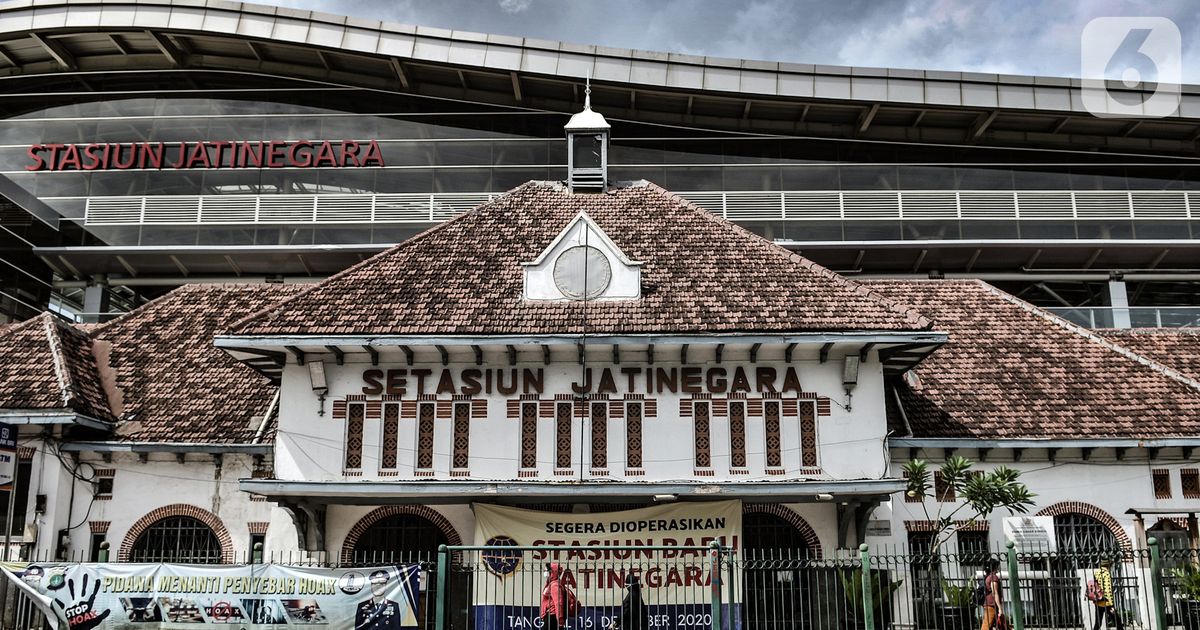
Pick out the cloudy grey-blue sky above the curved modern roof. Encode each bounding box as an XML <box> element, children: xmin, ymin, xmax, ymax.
<box><xmin>259</xmin><ymin>0</ymin><xmax>1200</xmax><ymax>83</ymax></box>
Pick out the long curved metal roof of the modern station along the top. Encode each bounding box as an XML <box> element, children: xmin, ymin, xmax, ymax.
<box><xmin>0</xmin><ymin>0</ymin><xmax>1200</xmax><ymax>155</ymax></box>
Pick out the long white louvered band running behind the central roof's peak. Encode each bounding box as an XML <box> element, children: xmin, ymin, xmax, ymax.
<box><xmin>84</xmin><ymin>191</ymin><xmax>1200</xmax><ymax>226</ymax></box>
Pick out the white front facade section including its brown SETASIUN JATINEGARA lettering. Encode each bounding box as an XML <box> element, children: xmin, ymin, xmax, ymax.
<box><xmin>275</xmin><ymin>346</ymin><xmax>887</xmax><ymax>481</ymax></box>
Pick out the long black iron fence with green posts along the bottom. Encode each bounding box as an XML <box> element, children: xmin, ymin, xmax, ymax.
<box><xmin>2</xmin><ymin>535</ymin><xmax>1200</xmax><ymax>630</ymax></box>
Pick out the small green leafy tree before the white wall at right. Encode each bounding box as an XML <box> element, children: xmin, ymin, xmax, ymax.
<box><xmin>904</xmin><ymin>455</ymin><xmax>1037</xmax><ymax>554</ymax></box>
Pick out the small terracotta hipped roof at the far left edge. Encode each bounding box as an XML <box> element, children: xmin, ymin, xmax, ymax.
<box><xmin>0</xmin><ymin>313</ymin><xmax>114</xmax><ymax>420</ymax></box>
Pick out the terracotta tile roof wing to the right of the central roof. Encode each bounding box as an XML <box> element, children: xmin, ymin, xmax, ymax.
<box><xmin>870</xmin><ymin>281</ymin><xmax>1200</xmax><ymax>439</ymax></box>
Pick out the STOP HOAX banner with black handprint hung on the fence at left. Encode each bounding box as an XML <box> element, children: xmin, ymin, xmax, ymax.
<box><xmin>6</xmin><ymin>563</ymin><xmax>420</xmax><ymax>630</ymax></box>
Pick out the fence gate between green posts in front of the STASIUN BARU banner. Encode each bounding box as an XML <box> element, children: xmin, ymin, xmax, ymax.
<box><xmin>433</xmin><ymin>545</ymin><xmax>729</xmax><ymax>630</ymax></box>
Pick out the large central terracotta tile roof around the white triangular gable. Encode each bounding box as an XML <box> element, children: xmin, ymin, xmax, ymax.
<box><xmin>234</xmin><ymin>182</ymin><xmax>929</xmax><ymax>335</ymax></box>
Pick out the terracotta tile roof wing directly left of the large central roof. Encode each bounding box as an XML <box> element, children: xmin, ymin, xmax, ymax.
<box><xmin>91</xmin><ymin>284</ymin><xmax>298</xmax><ymax>444</ymax></box>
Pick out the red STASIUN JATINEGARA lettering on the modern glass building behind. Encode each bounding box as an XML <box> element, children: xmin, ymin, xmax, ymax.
<box><xmin>25</xmin><ymin>140</ymin><xmax>384</xmax><ymax>170</ymax></box>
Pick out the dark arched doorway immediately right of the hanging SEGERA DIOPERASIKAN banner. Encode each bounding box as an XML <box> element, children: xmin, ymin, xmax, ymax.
<box><xmin>740</xmin><ymin>505</ymin><xmax>820</xmax><ymax>630</ymax></box>
